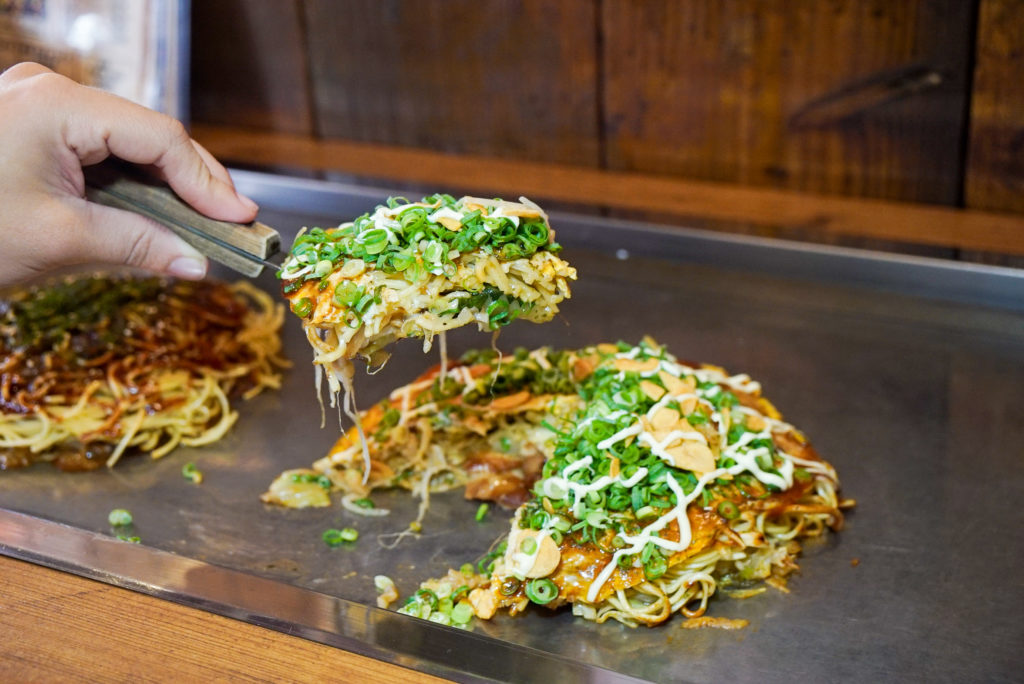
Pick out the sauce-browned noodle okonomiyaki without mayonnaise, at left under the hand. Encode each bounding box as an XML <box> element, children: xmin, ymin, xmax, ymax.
<box><xmin>0</xmin><ymin>275</ymin><xmax>286</xmax><ymax>470</ymax></box>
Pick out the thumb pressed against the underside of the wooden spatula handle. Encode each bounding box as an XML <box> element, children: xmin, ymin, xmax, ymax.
<box><xmin>77</xmin><ymin>202</ymin><xmax>207</xmax><ymax>281</ymax></box>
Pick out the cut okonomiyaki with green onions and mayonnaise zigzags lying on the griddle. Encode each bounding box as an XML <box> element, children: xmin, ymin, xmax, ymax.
<box><xmin>264</xmin><ymin>340</ymin><xmax>852</xmax><ymax>626</ymax></box>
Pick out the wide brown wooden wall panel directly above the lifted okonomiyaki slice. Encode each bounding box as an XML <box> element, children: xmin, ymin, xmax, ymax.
<box><xmin>306</xmin><ymin>0</ymin><xmax>599</xmax><ymax>165</ymax></box>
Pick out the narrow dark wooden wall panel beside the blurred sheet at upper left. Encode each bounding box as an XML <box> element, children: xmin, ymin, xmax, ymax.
<box><xmin>191</xmin><ymin>0</ymin><xmax>312</xmax><ymax>134</ymax></box>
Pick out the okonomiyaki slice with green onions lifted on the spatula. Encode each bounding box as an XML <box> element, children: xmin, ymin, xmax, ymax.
<box><xmin>279</xmin><ymin>195</ymin><xmax>575</xmax><ymax>481</ymax></box>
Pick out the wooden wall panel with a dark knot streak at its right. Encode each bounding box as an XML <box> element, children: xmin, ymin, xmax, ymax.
<box><xmin>602</xmin><ymin>0</ymin><xmax>972</xmax><ymax>204</ymax></box>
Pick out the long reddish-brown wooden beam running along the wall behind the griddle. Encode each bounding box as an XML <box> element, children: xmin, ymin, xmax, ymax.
<box><xmin>193</xmin><ymin>125</ymin><xmax>1024</xmax><ymax>254</ymax></box>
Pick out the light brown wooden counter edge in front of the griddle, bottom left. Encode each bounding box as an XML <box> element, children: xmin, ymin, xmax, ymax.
<box><xmin>0</xmin><ymin>556</ymin><xmax>441</xmax><ymax>684</ymax></box>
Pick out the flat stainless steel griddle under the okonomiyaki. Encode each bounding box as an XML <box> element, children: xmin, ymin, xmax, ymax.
<box><xmin>0</xmin><ymin>173</ymin><xmax>1024</xmax><ymax>682</ymax></box>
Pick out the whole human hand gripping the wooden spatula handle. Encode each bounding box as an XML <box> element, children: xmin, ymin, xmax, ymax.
<box><xmin>0</xmin><ymin>63</ymin><xmax>257</xmax><ymax>286</ymax></box>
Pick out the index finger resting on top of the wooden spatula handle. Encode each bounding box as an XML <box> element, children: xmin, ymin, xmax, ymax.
<box><xmin>55</xmin><ymin>81</ymin><xmax>258</xmax><ymax>222</ymax></box>
